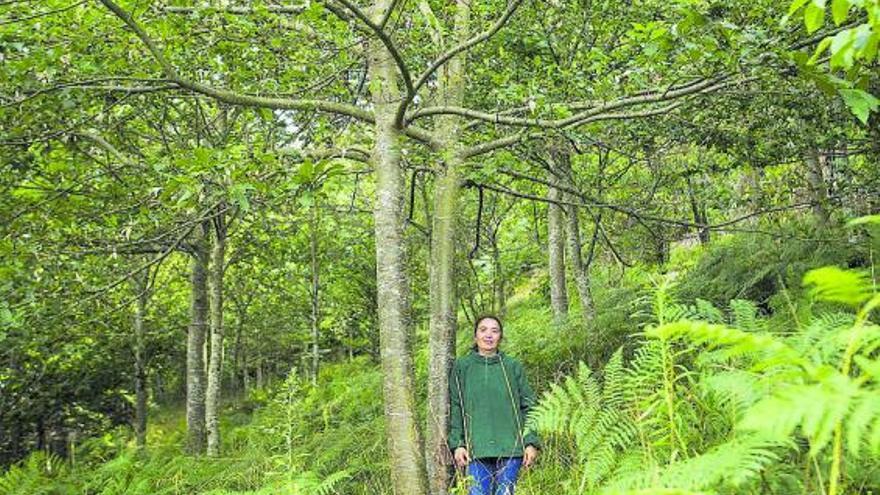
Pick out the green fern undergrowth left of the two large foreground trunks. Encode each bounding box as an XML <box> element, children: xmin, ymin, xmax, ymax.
<box><xmin>0</xmin><ymin>359</ymin><xmax>388</xmax><ymax>495</ymax></box>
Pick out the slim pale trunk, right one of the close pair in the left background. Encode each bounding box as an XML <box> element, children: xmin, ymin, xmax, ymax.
<box><xmin>205</xmin><ymin>211</ymin><xmax>226</xmax><ymax>457</ymax></box>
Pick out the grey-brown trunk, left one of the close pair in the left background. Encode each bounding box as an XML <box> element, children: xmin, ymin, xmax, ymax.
<box><xmin>186</xmin><ymin>223</ymin><xmax>209</xmax><ymax>454</ymax></box>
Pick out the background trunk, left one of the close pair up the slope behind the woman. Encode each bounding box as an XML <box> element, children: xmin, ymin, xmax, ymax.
<box><xmin>547</xmin><ymin>173</ymin><xmax>568</xmax><ymax>325</ymax></box>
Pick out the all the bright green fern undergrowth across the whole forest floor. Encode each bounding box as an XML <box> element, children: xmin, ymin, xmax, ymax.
<box><xmin>0</xmin><ymin>225</ymin><xmax>880</xmax><ymax>495</ymax></box>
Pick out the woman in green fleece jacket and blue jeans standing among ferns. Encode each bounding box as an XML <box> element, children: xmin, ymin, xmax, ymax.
<box><xmin>449</xmin><ymin>316</ymin><xmax>539</xmax><ymax>495</ymax></box>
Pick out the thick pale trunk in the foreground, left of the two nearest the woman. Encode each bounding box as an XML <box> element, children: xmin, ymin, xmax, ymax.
<box><xmin>368</xmin><ymin>13</ymin><xmax>427</xmax><ymax>495</ymax></box>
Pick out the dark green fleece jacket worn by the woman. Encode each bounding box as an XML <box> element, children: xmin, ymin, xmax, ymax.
<box><xmin>448</xmin><ymin>351</ymin><xmax>540</xmax><ymax>459</ymax></box>
